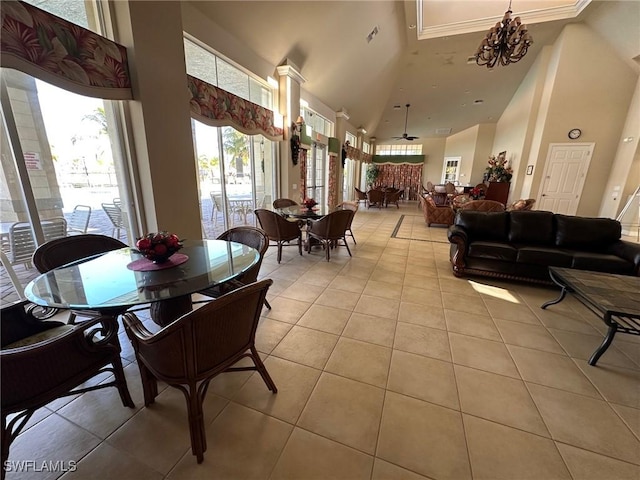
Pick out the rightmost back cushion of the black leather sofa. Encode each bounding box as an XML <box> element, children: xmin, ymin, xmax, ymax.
<box><xmin>555</xmin><ymin>214</ymin><xmax>622</xmax><ymax>250</ymax></box>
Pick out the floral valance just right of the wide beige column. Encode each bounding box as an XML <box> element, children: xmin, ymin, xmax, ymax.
<box><xmin>187</xmin><ymin>75</ymin><xmax>282</xmax><ymax>140</ymax></box>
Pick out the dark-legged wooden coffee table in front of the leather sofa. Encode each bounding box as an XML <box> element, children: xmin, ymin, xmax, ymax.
<box><xmin>541</xmin><ymin>267</ymin><xmax>640</xmax><ymax>365</ymax></box>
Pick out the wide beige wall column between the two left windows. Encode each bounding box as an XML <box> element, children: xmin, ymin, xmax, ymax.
<box><xmin>114</xmin><ymin>1</ymin><xmax>202</xmax><ymax>239</ymax></box>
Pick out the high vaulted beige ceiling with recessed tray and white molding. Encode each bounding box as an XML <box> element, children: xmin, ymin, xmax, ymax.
<box><xmin>193</xmin><ymin>0</ymin><xmax>640</xmax><ymax>143</ymax></box>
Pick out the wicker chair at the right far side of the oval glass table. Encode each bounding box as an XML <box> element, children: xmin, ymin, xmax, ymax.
<box><xmin>198</xmin><ymin>226</ymin><xmax>271</xmax><ymax>310</ymax></box>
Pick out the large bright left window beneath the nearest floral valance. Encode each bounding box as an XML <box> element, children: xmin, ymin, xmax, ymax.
<box><xmin>0</xmin><ymin>69</ymin><xmax>135</xmax><ymax>300</ymax></box>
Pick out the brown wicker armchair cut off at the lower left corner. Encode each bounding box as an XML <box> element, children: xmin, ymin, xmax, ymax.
<box><xmin>0</xmin><ymin>301</ymin><xmax>134</xmax><ymax>478</ymax></box>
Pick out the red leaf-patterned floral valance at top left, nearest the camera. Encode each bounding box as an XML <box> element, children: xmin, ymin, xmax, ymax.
<box><xmin>0</xmin><ymin>0</ymin><xmax>133</xmax><ymax>100</ymax></box>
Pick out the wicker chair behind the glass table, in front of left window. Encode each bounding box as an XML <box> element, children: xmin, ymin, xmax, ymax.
<box><xmin>32</xmin><ymin>234</ymin><xmax>127</xmax><ymax>324</ymax></box>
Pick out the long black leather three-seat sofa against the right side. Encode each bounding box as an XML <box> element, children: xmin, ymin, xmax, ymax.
<box><xmin>448</xmin><ymin>210</ymin><xmax>640</xmax><ymax>284</ymax></box>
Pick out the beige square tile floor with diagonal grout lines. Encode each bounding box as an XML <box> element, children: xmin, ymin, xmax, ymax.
<box><xmin>7</xmin><ymin>203</ymin><xmax>640</xmax><ymax>480</ymax></box>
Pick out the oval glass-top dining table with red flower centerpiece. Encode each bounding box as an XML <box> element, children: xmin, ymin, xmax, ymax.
<box><xmin>25</xmin><ymin>240</ymin><xmax>260</xmax><ymax>325</ymax></box>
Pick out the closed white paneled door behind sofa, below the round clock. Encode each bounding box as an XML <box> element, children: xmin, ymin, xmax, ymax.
<box><xmin>538</xmin><ymin>143</ymin><xmax>595</xmax><ymax>215</ymax></box>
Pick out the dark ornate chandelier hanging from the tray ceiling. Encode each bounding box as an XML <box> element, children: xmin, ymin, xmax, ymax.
<box><xmin>476</xmin><ymin>0</ymin><xmax>533</xmax><ymax>68</ymax></box>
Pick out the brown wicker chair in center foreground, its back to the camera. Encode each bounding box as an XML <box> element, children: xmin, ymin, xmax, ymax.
<box><xmin>123</xmin><ymin>280</ymin><xmax>278</xmax><ymax>463</ymax></box>
